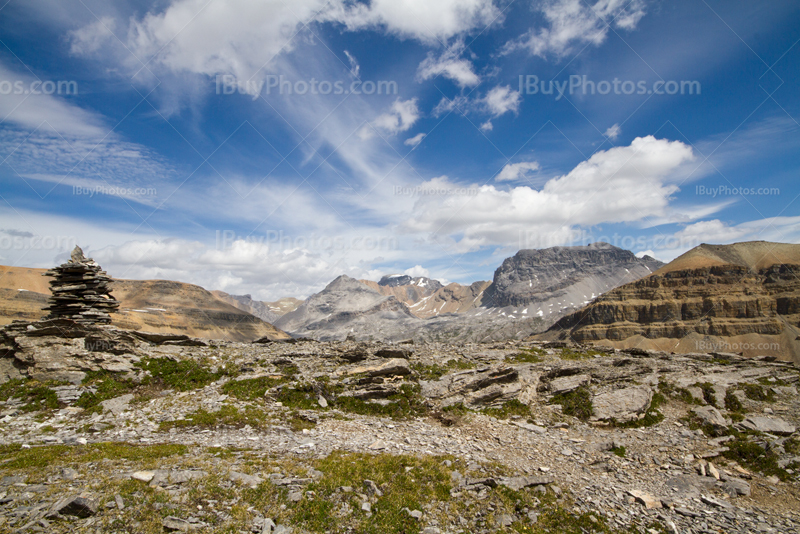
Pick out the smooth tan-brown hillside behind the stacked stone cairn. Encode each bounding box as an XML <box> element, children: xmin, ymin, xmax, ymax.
<box><xmin>0</xmin><ymin>267</ymin><xmax>289</xmax><ymax>341</ymax></box>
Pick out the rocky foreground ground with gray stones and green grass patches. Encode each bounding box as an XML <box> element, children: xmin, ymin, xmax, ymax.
<box><xmin>0</xmin><ymin>324</ymin><xmax>800</xmax><ymax>534</ymax></box>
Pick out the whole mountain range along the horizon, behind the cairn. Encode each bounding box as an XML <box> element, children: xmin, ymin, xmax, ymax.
<box><xmin>0</xmin><ymin>241</ymin><xmax>800</xmax><ymax>362</ymax></box>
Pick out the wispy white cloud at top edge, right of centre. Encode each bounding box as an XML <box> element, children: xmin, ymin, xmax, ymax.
<box><xmin>504</xmin><ymin>0</ymin><xmax>645</xmax><ymax>58</ymax></box>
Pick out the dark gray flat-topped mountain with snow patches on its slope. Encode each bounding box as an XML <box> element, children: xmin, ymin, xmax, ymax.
<box><xmin>483</xmin><ymin>243</ymin><xmax>664</xmax><ymax>307</ymax></box>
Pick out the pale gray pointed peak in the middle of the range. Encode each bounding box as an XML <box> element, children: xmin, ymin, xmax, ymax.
<box><xmin>275</xmin><ymin>275</ymin><xmax>416</xmax><ymax>340</ymax></box>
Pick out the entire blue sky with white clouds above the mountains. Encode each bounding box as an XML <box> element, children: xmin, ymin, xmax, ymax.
<box><xmin>0</xmin><ymin>0</ymin><xmax>800</xmax><ymax>300</ymax></box>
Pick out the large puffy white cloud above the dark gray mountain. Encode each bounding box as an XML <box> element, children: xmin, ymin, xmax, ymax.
<box><xmin>405</xmin><ymin>136</ymin><xmax>694</xmax><ymax>250</ymax></box>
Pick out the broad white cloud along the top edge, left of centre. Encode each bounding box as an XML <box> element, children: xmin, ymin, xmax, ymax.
<box><xmin>70</xmin><ymin>0</ymin><xmax>501</xmax><ymax>80</ymax></box>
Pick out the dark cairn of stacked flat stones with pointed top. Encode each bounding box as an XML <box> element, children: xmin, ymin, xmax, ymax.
<box><xmin>44</xmin><ymin>246</ymin><xmax>119</xmax><ymax>324</ymax></box>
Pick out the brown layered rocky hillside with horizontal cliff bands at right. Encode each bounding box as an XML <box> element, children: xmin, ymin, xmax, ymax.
<box><xmin>548</xmin><ymin>241</ymin><xmax>800</xmax><ymax>362</ymax></box>
